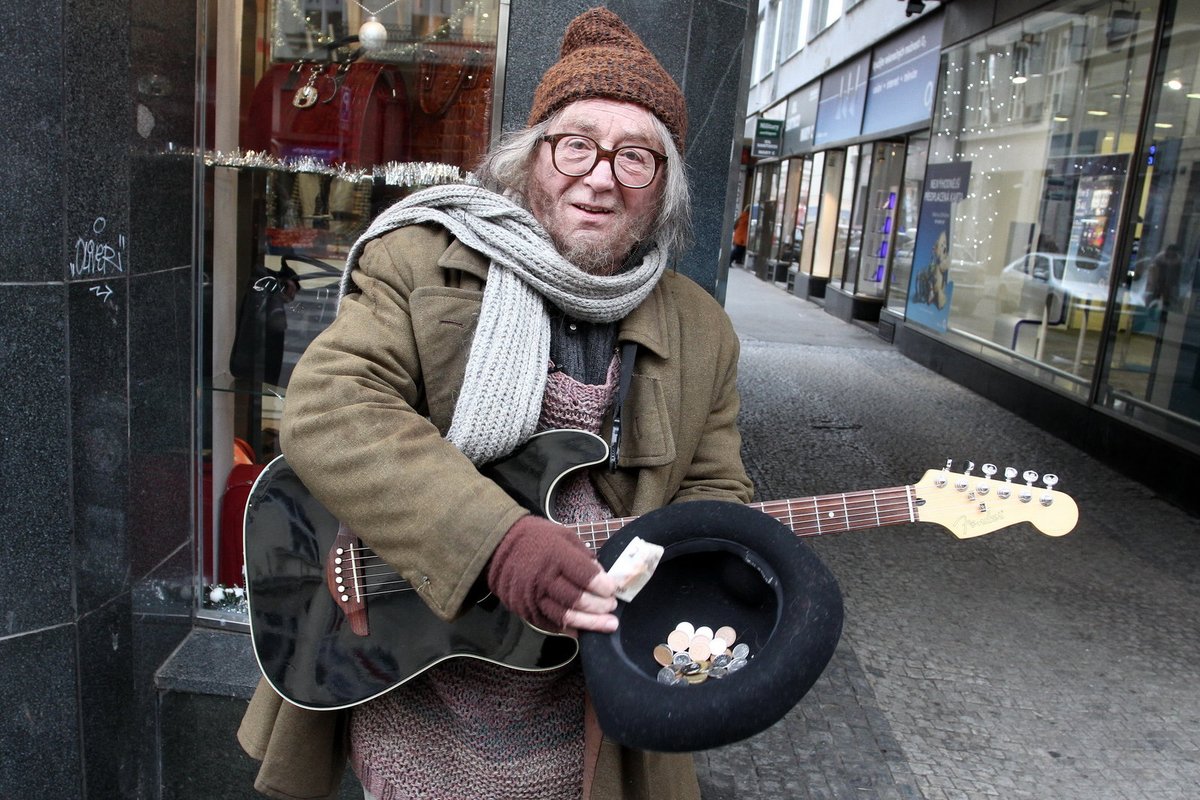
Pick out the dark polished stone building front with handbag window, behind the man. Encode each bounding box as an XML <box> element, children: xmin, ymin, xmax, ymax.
<box><xmin>0</xmin><ymin>0</ymin><xmax>751</xmax><ymax>799</ymax></box>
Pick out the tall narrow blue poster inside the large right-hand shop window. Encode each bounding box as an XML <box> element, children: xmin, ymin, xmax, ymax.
<box><xmin>906</xmin><ymin>161</ymin><xmax>971</xmax><ymax>333</ymax></box>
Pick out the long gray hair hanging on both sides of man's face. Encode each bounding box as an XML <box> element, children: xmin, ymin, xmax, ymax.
<box><xmin>474</xmin><ymin>112</ymin><xmax>691</xmax><ymax>258</ymax></box>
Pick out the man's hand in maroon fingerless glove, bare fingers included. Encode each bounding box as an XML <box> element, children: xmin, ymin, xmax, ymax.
<box><xmin>487</xmin><ymin>515</ymin><xmax>617</xmax><ymax>633</ymax></box>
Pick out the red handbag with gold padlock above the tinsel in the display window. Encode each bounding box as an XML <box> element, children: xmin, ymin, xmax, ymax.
<box><xmin>240</xmin><ymin>61</ymin><xmax>408</xmax><ymax>167</ymax></box>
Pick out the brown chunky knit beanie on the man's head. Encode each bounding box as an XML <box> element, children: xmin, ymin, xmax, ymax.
<box><xmin>529</xmin><ymin>8</ymin><xmax>688</xmax><ymax>152</ymax></box>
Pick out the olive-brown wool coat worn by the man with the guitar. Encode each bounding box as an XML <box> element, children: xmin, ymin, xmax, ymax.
<box><xmin>238</xmin><ymin>225</ymin><xmax>751</xmax><ymax>800</ymax></box>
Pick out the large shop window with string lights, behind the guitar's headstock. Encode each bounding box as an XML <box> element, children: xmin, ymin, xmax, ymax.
<box><xmin>905</xmin><ymin>0</ymin><xmax>1158</xmax><ymax>398</ymax></box>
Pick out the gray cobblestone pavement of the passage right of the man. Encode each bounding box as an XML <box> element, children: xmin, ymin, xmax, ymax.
<box><xmin>696</xmin><ymin>270</ymin><xmax>1200</xmax><ymax>800</ymax></box>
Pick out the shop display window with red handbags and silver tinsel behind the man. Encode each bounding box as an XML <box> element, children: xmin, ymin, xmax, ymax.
<box><xmin>196</xmin><ymin>0</ymin><xmax>505</xmax><ymax>621</ymax></box>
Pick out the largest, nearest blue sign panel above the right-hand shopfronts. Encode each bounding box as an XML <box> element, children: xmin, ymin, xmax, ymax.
<box><xmin>863</xmin><ymin>18</ymin><xmax>942</xmax><ymax>136</ymax></box>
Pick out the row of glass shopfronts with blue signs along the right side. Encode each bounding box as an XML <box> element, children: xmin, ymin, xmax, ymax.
<box><xmin>728</xmin><ymin>0</ymin><xmax>1200</xmax><ymax>507</ymax></box>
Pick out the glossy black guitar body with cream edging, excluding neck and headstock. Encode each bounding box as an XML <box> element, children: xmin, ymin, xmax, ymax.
<box><xmin>245</xmin><ymin>431</ymin><xmax>608</xmax><ymax>710</ymax></box>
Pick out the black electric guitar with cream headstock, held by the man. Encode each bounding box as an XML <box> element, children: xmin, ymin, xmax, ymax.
<box><xmin>245</xmin><ymin>431</ymin><xmax>1079</xmax><ymax>710</ymax></box>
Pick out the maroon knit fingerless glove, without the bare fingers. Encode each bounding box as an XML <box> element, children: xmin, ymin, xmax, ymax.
<box><xmin>487</xmin><ymin>515</ymin><xmax>600</xmax><ymax>632</ymax></box>
